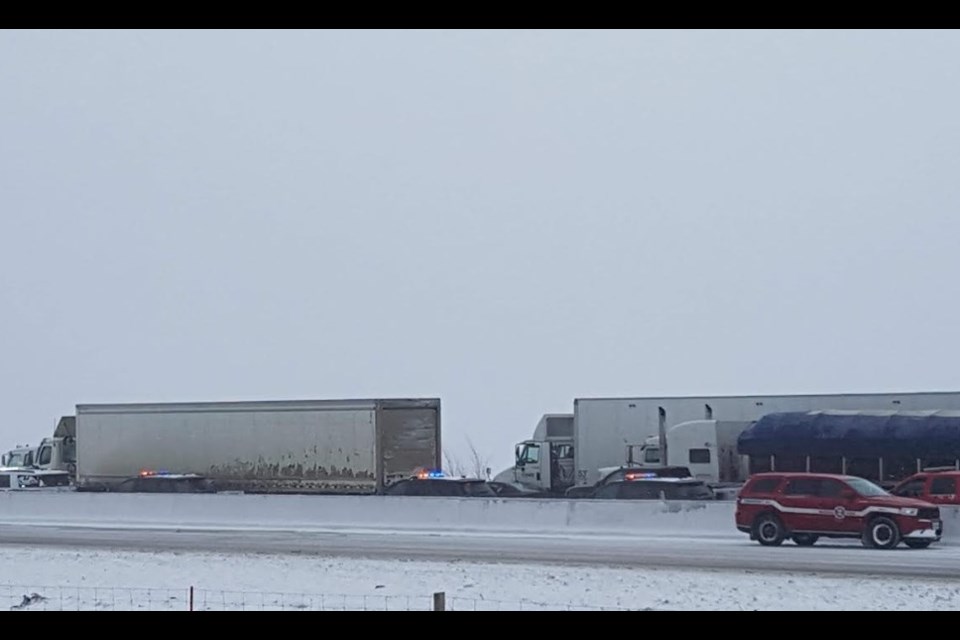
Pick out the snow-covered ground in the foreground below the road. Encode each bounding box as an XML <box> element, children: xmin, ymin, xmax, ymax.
<box><xmin>0</xmin><ymin>546</ymin><xmax>960</xmax><ymax>610</ymax></box>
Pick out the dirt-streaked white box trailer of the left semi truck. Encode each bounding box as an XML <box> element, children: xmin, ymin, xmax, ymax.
<box><xmin>76</xmin><ymin>399</ymin><xmax>441</xmax><ymax>494</ymax></box>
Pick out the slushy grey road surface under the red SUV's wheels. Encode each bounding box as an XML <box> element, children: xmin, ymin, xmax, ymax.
<box><xmin>0</xmin><ymin>524</ymin><xmax>960</xmax><ymax>579</ymax></box>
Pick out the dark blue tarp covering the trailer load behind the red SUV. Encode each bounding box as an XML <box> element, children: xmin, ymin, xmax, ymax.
<box><xmin>737</xmin><ymin>411</ymin><xmax>960</xmax><ymax>459</ymax></box>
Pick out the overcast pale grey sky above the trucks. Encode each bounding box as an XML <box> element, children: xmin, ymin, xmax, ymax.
<box><xmin>0</xmin><ymin>31</ymin><xmax>960</xmax><ymax>472</ymax></box>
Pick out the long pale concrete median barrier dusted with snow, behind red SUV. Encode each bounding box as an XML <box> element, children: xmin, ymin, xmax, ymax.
<box><xmin>0</xmin><ymin>492</ymin><xmax>960</xmax><ymax>540</ymax></box>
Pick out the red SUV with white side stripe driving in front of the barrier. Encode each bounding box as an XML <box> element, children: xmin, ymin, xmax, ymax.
<box><xmin>736</xmin><ymin>473</ymin><xmax>943</xmax><ymax>549</ymax></box>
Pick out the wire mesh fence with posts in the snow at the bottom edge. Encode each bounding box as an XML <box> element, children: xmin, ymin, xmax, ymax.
<box><xmin>0</xmin><ymin>584</ymin><xmax>649</xmax><ymax>611</ymax></box>
